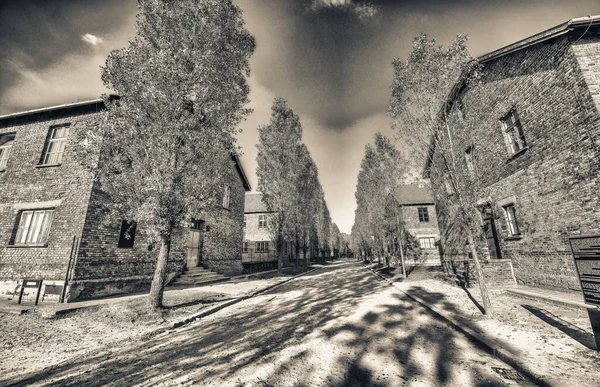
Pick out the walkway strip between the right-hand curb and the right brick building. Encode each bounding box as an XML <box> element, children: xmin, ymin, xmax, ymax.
<box><xmin>364</xmin><ymin>264</ymin><xmax>600</xmax><ymax>386</ymax></box>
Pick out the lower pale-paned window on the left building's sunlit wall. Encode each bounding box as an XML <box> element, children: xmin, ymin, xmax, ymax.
<box><xmin>9</xmin><ymin>208</ymin><xmax>56</xmax><ymax>247</ymax></box>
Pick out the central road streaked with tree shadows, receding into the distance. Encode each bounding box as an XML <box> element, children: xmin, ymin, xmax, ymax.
<box><xmin>8</xmin><ymin>263</ymin><xmax>536</xmax><ymax>386</ymax></box>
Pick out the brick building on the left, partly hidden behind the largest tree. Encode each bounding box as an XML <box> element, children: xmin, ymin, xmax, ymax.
<box><xmin>0</xmin><ymin>100</ymin><xmax>250</xmax><ymax>302</ymax></box>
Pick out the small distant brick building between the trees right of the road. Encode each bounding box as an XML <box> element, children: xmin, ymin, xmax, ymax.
<box><xmin>390</xmin><ymin>182</ymin><xmax>441</xmax><ymax>266</ymax></box>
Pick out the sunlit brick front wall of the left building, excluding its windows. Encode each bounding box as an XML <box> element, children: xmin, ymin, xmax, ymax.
<box><xmin>0</xmin><ymin>107</ymin><xmax>97</xmax><ymax>299</ymax></box>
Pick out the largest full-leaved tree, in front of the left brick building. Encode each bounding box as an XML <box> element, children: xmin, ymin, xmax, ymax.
<box><xmin>80</xmin><ymin>0</ymin><xmax>255</xmax><ymax>308</ymax></box>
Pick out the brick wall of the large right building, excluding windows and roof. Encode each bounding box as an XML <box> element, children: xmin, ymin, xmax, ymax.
<box><xmin>434</xmin><ymin>34</ymin><xmax>600</xmax><ymax>290</ymax></box>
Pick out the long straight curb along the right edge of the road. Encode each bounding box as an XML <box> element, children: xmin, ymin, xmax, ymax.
<box><xmin>363</xmin><ymin>266</ymin><xmax>551</xmax><ymax>387</ymax></box>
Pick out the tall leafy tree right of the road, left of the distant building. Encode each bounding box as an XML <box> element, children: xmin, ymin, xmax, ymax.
<box><xmin>353</xmin><ymin>133</ymin><xmax>406</xmax><ymax>264</ymax></box>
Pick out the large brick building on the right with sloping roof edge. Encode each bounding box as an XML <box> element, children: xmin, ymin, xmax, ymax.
<box><xmin>430</xmin><ymin>16</ymin><xmax>600</xmax><ymax>291</ymax></box>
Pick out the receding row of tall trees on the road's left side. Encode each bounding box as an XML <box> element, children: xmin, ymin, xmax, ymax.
<box><xmin>256</xmin><ymin>97</ymin><xmax>342</xmax><ymax>269</ymax></box>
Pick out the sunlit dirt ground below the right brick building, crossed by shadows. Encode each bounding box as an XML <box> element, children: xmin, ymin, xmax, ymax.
<box><xmin>399</xmin><ymin>278</ymin><xmax>600</xmax><ymax>387</ymax></box>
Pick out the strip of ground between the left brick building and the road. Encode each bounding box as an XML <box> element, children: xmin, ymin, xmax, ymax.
<box><xmin>0</xmin><ymin>268</ymin><xmax>317</xmax><ymax>378</ymax></box>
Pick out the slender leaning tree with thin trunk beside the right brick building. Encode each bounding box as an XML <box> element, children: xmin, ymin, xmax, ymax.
<box><xmin>389</xmin><ymin>34</ymin><xmax>493</xmax><ymax>315</ymax></box>
